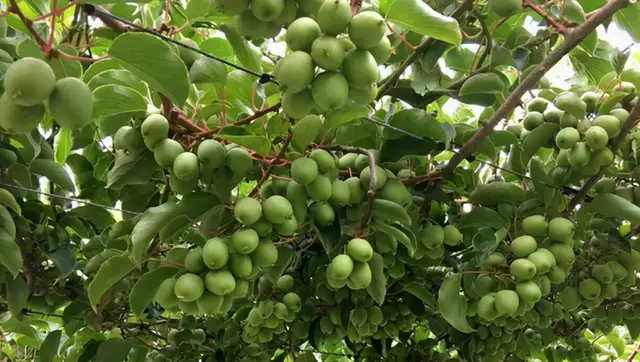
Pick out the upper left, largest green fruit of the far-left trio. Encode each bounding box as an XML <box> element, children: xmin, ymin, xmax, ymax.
<box><xmin>3</xmin><ymin>58</ymin><xmax>55</xmax><ymax>106</ymax></box>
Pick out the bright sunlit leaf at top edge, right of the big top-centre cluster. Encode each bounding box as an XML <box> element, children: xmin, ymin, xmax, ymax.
<box><xmin>380</xmin><ymin>0</ymin><xmax>462</xmax><ymax>46</ymax></box>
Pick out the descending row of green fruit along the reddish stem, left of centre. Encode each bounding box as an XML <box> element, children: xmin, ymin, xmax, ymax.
<box><xmin>113</xmin><ymin>114</ymin><xmax>253</xmax><ymax>195</ymax></box>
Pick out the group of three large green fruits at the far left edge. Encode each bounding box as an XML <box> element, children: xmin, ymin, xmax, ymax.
<box><xmin>0</xmin><ymin>58</ymin><xmax>93</xmax><ymax>134</ymax></box>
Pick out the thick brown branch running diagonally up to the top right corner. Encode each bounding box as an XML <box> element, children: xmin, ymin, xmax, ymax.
<box><xmin>432</xmin><ymin>0</ymin><xmax>629</xmax><ymax>177</ymax></box>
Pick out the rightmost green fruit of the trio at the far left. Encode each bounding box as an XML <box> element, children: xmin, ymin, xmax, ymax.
<box><xmin>47</xmin><ymin>77</ymin><xmax>93</xmax><ymax>130</ymax></box>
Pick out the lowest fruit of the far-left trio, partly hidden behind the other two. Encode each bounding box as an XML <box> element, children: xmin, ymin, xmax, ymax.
<box><xmin>0</xmin><ymin>92</ymin><xmax>46</xmax><ymax>134</ymax></box>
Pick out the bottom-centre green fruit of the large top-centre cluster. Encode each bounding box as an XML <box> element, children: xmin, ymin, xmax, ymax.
<box><xmin>311</xmin><ymin>72</ymin><xmax>349</xmax><ymax>112</ymax></box>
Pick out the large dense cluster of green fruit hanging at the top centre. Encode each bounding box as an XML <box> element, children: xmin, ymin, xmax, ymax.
<box><xmin>274</xmin><ymin>0</ymin><xmax>391</xmax><ymax>119</ymax></box>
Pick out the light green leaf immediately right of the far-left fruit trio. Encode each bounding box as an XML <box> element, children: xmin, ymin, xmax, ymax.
<box><xmin>93</xmin><ymin>84</ymin><xmax>147</xmax><ymax>117</ymax></box>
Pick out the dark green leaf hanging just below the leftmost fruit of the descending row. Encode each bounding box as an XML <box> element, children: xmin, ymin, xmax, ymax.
<box><xmin>107</xmin><ymin>149</ymin><xmax>159</xmax><ymax>190</ymax></box>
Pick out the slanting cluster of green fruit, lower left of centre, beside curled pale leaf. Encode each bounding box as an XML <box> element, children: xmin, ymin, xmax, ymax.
<box><xmin>155</xmin><ymin>235</ymin><xmax>278</xmax><ymax>315</ymax></box>
